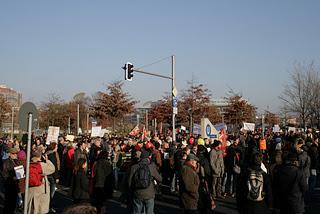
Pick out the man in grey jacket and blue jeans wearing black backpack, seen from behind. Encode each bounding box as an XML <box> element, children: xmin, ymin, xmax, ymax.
<box><xmin>128</xmin><ymin>149</ymin><xmax>162</xmax><ymax>214</ymax></box>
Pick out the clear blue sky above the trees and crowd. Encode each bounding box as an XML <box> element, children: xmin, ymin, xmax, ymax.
<box><xmin>0</xmin><ymin>0</ymin><xmax>320</xmax><ymax>111</ymax></box>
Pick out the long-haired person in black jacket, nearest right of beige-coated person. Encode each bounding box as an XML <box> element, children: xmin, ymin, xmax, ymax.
<box><xmin>72</xmin><ymin>158</ymin><xmax>90</xmax><ymax>204</ymax></box>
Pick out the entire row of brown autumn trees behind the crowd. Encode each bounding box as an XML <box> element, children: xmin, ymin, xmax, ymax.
<box><xmin>0</xmin><ymin>73</ymin><xmax>296</xmax><ymax>133</ymax></box>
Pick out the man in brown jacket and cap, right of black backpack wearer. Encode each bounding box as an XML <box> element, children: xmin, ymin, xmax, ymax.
<box><xmin>180</xmin><ymin>154</ymin><xmax>200</xmax><ymax>214</ymax></box>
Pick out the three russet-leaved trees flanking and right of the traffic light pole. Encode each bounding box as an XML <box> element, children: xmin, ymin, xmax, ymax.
<box><xmin>150</xmin><ymin>81</ymin><xmax>256</xmax><ymax>129</ymax></box>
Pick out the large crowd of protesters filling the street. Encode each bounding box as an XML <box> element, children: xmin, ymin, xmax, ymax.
<box><xmin>0</xmin><ymin>130</ymin><xmax>320</xmax><ymax>214</ymax></box>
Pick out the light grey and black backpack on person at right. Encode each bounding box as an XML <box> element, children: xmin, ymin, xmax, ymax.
<box><xmin>247</xmin><ymin>169</ymin><xmax>264</xmax><ymax>201</ymax></box>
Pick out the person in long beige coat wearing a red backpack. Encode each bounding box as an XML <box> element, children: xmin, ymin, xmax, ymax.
<box><xmin>26</xmin><ymin>151</ymin><xmax>55</xmax><ymax>214</ymax></box>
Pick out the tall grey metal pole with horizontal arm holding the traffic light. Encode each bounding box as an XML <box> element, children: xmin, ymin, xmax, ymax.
<box><xmin>128</xmin><ymin>55</ymin><xmax>177</xmax><ymax>142</ymax></box>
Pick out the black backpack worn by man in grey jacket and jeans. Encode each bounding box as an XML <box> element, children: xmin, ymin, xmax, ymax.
<box><xmin>133</xmin><ymin>164</ymin><xmax>151</xmax><ymax>189</ymax></box>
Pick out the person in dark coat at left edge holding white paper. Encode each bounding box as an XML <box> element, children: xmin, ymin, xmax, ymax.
<box><xmin>1</xmin><ymin>148</ymin><xmax>19</xmax><ymax>214</ymax></box>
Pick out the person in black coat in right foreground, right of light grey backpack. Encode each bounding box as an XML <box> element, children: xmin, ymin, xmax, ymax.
<box><xmin>273</xmin><ymin>152</ymin><xmax>308</xmax><ymax>214</ymax></box>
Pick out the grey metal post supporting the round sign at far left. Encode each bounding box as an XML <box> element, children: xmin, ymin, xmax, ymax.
<box><xmin>23</xmin><ymin>113</ymin><xmax>32</xmax><ymax>214</ymax></box>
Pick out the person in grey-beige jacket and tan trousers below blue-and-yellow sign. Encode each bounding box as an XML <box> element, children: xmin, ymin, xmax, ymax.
<box><xmin>210</xmin><ymin>140</ymin><xmax>224</xmax><ymax>198</ymax></box>
